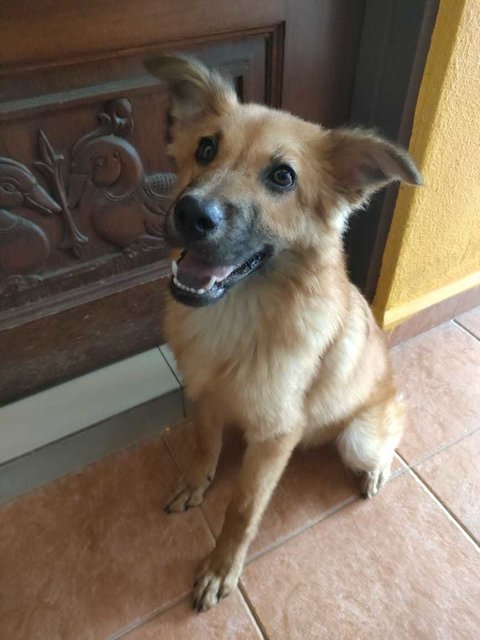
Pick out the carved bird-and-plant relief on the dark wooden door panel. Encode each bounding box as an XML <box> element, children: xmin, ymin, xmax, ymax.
<box><xmin>0</xmin><ymin>98</ymin><xmax>175</xmax><ymax>293</ymax></box>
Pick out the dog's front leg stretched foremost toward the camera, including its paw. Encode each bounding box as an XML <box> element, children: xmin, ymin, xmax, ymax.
<box><xmin>193</xmin><ymin>432</ymin><xmax>299</xmax><ymax>611</ymax></box>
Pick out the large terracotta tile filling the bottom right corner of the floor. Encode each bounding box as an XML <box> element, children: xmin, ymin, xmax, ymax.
<box><xmin>242</xmin><ymin>474</ymin><xmax>480</xmax><ymax>640</ymax></box>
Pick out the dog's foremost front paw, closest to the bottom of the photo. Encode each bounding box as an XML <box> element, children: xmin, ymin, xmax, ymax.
<box><xmin>193</xmin><ymin>559</ymin><xmax>241</xmax><ymax>613</ymax></box>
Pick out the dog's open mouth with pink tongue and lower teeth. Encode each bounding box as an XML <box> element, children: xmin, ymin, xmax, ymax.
<box><xmin>170</xmin><ymin>247</ymin><xmax>272</xmax><ymax>307</ymax></box>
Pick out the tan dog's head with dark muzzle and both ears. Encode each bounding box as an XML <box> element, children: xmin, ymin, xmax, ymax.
<box><xmin>147</xmin><ymin>57</ymin><xmax>421</xmax><ymax>306</ymax></box>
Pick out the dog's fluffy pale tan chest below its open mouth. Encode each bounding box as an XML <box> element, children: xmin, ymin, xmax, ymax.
<box><xmin>167</xmin><ymin>297</ymin><xmax>330</xmax><ymax>426</ymax></box>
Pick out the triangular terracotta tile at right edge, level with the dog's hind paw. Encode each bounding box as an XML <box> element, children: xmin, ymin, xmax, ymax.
<box><xmin>416</xmin><ymin>429</ymin><xmax>480</xmax><ymax>540</ymax></box>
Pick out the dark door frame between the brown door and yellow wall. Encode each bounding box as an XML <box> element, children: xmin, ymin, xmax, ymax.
<box><xmin>345</xmin><ymin>0</ymin><xmax>439</xmax><ymax>301</ymax></box>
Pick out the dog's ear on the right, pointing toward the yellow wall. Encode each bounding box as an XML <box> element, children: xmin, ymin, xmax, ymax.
<box><xmin>327</xmin><ymin>129</ymin><xmax>422</xmax><ymax>204</ymax></box>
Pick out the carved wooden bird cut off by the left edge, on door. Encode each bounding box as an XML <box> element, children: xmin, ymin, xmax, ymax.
<box><xmin>0</xmin><ymin>158</ymin><xmax>60</xmax><ymax>292</ymax></box>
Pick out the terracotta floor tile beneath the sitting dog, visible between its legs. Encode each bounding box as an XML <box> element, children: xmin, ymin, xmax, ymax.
<box><xmin>168</xmin><ymin>423</ymin><xmax>401</xmax><ymax>554</ymax></box>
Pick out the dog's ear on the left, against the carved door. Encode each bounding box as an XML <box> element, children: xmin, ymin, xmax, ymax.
<box><xmin>145</xmin><ymin>56</ymin><xmax>238</xmax><ymax>124</ymax></box>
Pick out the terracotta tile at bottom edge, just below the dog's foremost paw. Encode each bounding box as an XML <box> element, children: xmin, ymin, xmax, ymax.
<box><xmin>125</xmin><ymin>591</ymin><xmax>261</xmax><ymax>640</ymax></box>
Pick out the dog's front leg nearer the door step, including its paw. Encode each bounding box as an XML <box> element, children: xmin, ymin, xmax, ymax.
<box><xmin>165</xmin><ymin>400</ymin><xmax>223</xmax><ymax>513</ymax></box>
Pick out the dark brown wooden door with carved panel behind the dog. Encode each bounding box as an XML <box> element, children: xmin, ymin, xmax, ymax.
<box><xmin>0</xmin><ymin>0</ymin><xmax>363</xmax><ymax>402</ymax></box>
